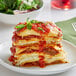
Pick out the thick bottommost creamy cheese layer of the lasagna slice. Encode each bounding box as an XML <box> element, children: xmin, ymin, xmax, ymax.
<box><xmin>16</xmin><ymin>52</ymin><xmax>66</xmax><ymax>65</ymax></box>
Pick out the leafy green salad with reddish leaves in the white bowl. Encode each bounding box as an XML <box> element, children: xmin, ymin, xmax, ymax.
<box><xmin>0</xmin><ymin>0</ymin><xmax>43</xmax><ymax>14</ymax></box>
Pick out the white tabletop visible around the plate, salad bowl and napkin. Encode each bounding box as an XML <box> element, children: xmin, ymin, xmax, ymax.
<box><xmin>0</xmin><ymin>0</ymin><xmax>76</xmax><ymax>76</ymax></box>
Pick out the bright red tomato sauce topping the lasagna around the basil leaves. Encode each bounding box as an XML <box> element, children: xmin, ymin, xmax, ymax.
<box><xmin>16</xmin><ymin>22</ymin><xmax>51</xmax><ymax>34</ymax></box>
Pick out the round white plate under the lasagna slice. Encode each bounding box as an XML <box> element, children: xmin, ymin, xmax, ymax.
<box><xmin>0</xmin><ymin>40</ymin><xmax>76</xmax><ymax>75</ymax></box>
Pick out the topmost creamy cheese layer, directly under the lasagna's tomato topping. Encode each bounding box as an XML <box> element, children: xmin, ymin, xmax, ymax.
<box><xmin>17</xmin><ymin>28</ymin><xmax>59</xmax><ymax>37</ymax></box>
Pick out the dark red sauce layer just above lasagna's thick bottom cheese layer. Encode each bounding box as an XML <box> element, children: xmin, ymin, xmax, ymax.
<box><xmin>11</xmin><ymin>46</ymin><xmax>59</xmax><ymax>56</ymax></box>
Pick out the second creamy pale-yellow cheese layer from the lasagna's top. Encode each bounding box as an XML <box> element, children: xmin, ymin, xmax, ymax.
<box><xmin>13</xmin><ymin>37</ymin><xmax>61</xmax><ymax>46</ymax></box>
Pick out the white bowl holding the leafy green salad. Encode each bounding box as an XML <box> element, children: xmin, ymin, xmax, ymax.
<box><xmin>0</xmin><ymin>0</ymin><xmax>44</xmax><ymax>25</ymax></box>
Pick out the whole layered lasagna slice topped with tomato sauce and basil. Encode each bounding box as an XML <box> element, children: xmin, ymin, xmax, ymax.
<box><xmin>9</xmin><ymin>20</ymin><xmax>67</xmax><ymax>68</ymax></box>
